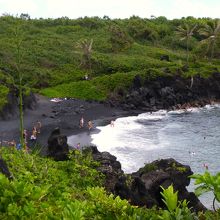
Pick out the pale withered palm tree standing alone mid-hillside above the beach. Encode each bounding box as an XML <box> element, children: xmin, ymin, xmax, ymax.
<box><xmin>76</xmin><ymin>39</ymin><xmax>93</xmax><ymax>71</ymax></box>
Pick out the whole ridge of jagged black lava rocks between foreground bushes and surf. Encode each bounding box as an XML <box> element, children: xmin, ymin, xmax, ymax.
<box><xmin>83</xmin><ymin>146</ymin><xmax>206</xmax><ymax>212</ymax></box>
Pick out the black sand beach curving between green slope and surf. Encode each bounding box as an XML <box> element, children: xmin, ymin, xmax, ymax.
<box><xmin>0</xmin><ymin>95</ymin><xmax>130</xmax><ymax>153</ymax></box>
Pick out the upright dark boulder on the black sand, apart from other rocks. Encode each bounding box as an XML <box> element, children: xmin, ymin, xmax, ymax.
<box><xmin>47</xmin><ymin>128</ymin><xmax>69</xmax><ymax>161</ymax></box>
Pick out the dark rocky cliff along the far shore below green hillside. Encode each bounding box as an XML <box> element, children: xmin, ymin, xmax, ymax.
<box><xmin>109</xmin><ymin>72</ymin><xmax>220</xmax><ymax>111</ymax></box>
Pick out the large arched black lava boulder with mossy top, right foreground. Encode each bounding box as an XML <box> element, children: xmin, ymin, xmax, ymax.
<box><xmin>132</xmin><ymin>158</ymin><xmax>206</xmax><ymax>212</ymax></box>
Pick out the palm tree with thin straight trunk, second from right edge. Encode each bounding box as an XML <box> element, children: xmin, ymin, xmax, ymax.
<box><xmin>176</xmin><ymin>23</ymin><xmax>197</xmax><ymax>66</ymax></box>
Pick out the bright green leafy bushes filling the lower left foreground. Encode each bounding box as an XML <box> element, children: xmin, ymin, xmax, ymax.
<box><xmin>0</xmin><ymin>148</ymin><xmax>157</xmax><ymax>220</ymax></box>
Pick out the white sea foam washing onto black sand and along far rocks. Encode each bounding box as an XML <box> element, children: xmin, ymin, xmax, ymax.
<box><xmin>69</xmin><ymin>105</ymin><xmax>220</xmax><ymax>172</ymax></box>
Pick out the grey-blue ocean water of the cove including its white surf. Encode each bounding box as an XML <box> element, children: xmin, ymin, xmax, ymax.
<box><xmin>92</xmin><ymin>105</ymin><xmax>220</xmax><ymax>208</ymax></box>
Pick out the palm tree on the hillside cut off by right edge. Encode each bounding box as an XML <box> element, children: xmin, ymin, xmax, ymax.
<box><xmin>199</xmin><ymin>19</ymin><xmax>220</xmax><ymax>60</ymax></box>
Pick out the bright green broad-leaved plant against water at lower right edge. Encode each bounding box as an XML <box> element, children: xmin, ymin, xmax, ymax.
<box><xmin>190</xmin><ymin>171</ymin><xmax>220</xmax><ymax>211</ymax></box>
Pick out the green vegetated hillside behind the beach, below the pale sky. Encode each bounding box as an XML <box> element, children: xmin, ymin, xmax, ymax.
<box><xmin>0</xmin><ymin>14</ymin><xmax>220</xmax><ymax>106</ymax></box>
